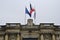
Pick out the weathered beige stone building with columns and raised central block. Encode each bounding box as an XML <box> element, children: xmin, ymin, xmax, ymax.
<box><xmin>0</xmin><ymin>19</ymin><xmax>60</xmax><ymax>40</ymax></box>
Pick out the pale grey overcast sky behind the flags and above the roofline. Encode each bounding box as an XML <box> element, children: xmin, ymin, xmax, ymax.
<box><xmin>0</xmin><ymin>0</ymin><xmax>60</xmax><ymax>25</ymax></box>
